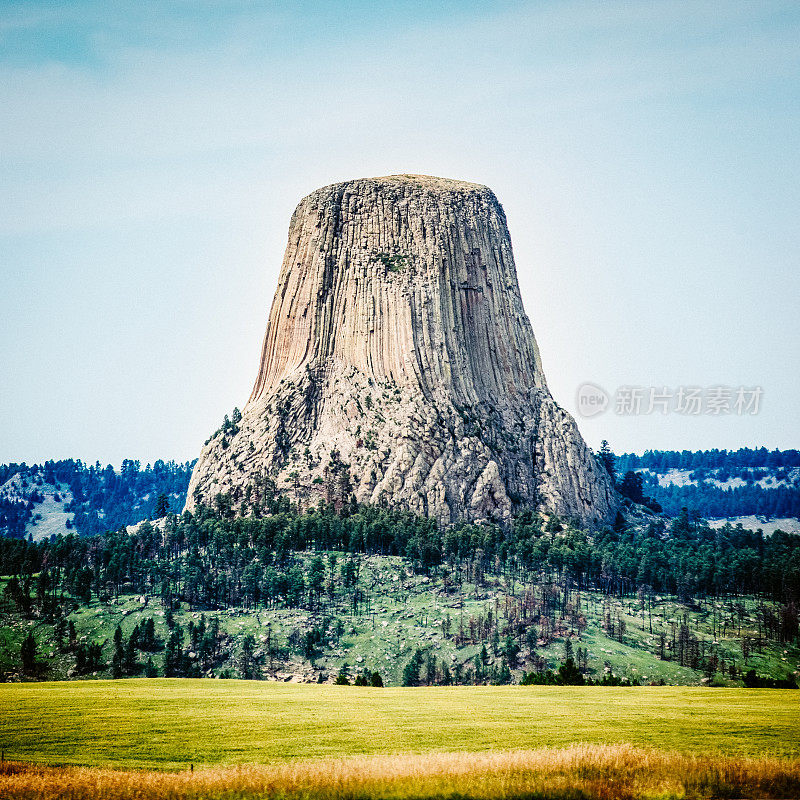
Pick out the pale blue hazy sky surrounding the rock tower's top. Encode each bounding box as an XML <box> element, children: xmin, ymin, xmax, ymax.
<box><xmin>0</xmin><ymin>0</ymin><xmax>800</xmax><ymax>465</ymax></box>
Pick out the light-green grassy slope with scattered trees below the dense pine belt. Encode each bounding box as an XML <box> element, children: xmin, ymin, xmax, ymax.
<box><xmin>0</xmin><ymin>568</ymin><xmax>800</xmax><ymax>685</ymax></box>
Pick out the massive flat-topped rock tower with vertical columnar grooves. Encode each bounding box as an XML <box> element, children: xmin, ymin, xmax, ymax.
<box><xmin>188</xmin><ymin>175</ymin><xmax>616</xmax><ymax>524</ymax></box>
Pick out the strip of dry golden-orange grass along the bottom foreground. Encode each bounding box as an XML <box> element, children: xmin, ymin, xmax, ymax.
<box><xmin>0</xmin><ymin>745</ymin><xmax>800</xmax><ymax>800</ymax></box>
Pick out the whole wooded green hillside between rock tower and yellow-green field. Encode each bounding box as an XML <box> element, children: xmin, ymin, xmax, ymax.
<box><xmin>0</xmin><ymin>496</ymin><xmax>800</xmax><ymax>685</ymax></box>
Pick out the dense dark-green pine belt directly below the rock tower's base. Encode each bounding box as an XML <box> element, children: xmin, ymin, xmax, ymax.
<box><xmin>0</xmin><ymin>494</ymin><xmax>800</xmax><ymax>608</ymax></box>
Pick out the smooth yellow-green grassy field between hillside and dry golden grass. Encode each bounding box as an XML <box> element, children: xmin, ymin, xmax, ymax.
<box><xmin>0</xmin><ymin>679</ymin><xmax>800</xmax><ymax>769</ymax></box>
